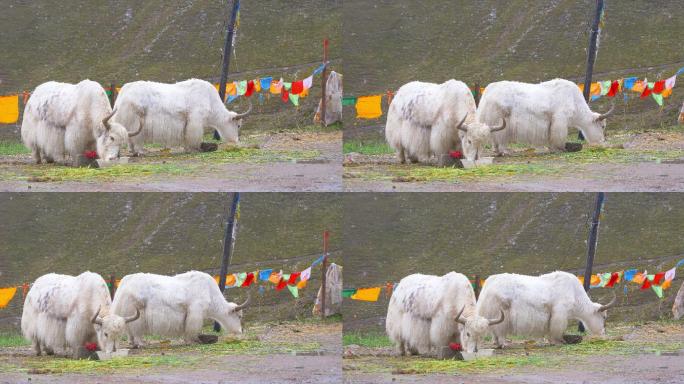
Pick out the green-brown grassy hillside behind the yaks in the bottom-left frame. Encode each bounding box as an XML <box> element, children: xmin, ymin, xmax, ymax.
<box><xmin>0</xmin><ymin>193</ymin><xmax>342</xmax><ymax>332</ymax></box>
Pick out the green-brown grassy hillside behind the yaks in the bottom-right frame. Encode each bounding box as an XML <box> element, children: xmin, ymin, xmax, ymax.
<box><xmin>343</xmin><ymin>193</ymin><xmax>684</xmax><ymax>329</ymax></box>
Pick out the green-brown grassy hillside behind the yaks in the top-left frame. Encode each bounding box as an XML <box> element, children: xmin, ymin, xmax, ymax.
<box><xmin>0</xmin><ymin>0</ymin><xmax>341</xmax><ymax>134</ymax></box>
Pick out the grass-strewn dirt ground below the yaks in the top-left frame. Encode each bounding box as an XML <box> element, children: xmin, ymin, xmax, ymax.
<box><xmin>0</xmin><ymin>132</ymin><xmax>342</xmax><ymax>192</ymax></box>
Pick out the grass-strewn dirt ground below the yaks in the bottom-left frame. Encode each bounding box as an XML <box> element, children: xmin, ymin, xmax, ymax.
<box><xmin>0</xmin><ymin>322</ymin><xmax>342</xmax><ymax>384</ymax></box>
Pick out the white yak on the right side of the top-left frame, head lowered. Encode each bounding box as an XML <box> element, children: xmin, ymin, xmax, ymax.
<box><xmin>113</xmin><ymin>79</ymin><xmax>252</xmax><ymax>156</ymax></box>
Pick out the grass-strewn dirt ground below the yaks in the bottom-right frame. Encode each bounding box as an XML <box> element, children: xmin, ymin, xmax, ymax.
<box><xmin>343</xmin><ymin>323</ymin><xmax>684</xmax><ymax>384</ymax></box>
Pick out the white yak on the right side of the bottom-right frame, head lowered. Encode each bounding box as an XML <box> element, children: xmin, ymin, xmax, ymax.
<box><xmin>477</xmin><ymin>272</ymin><xmax>616</xmax><ymax>348</ymax></box>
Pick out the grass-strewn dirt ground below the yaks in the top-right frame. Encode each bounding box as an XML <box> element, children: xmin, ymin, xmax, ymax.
<box><xmin>343</xmin><ymin>131</ymin><xmax>684</xmax><ymax>192</ymax></box>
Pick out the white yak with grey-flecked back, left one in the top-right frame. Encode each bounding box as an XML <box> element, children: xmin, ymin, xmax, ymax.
<box><xmin>385</xmin><ymin>79</ymin><xmax>505</xmax><ymax>164</ymax></box>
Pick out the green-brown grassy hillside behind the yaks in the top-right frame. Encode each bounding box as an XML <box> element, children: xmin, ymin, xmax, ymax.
<box><xmin>343</xmin><ymin>0</ymin><xmax>684</xmax><ymax>136</ymax></box>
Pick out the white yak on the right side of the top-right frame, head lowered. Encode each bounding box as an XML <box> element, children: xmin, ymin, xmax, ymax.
<box><xmin>476</xmin><ymin>79</ymin><xmax>615</xmax><ymax>156</ymax></box>
